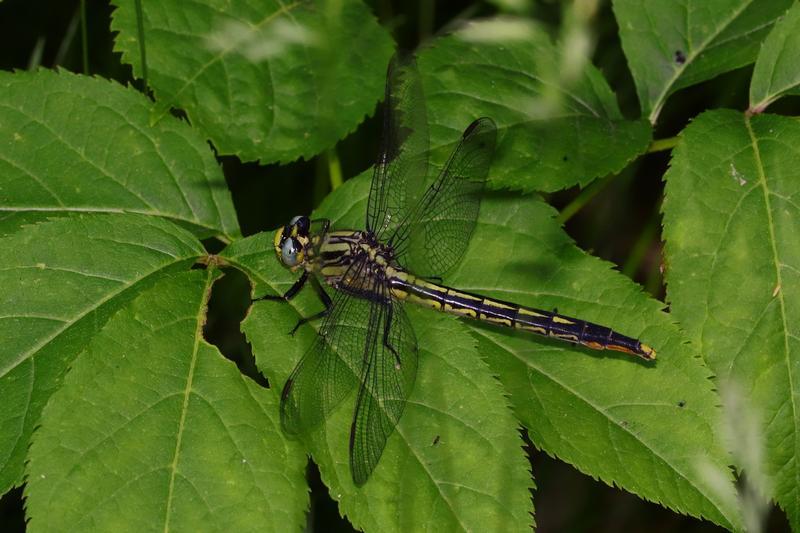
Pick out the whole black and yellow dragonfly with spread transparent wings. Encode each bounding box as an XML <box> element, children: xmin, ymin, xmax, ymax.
<box><xmin>262</xmin><ymin>59</ymin><xmax>656</xmax><ymax>486</ymax></box>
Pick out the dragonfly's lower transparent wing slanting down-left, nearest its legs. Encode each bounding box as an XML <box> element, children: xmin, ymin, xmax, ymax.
<box><xmin>281</xmin><ymin>261</ymin><xmax>370</xmax><ymax>435</ymax></box>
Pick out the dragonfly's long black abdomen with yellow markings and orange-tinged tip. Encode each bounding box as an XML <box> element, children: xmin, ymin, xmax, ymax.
<box><xmin>391</xmin><ymin>272</ymin><xmax>656</xmax><ymax>360</ymax></box>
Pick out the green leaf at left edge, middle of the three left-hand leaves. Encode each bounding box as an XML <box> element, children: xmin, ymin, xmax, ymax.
<box><xmin>0</xmin><ymin>214</ymin><xmax>205</xmax><ymax>493</ymax></box>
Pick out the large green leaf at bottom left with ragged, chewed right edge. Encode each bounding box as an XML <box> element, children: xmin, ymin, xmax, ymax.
<box><xmin>26</xmin><ymin>270</ymin><xmax>308</xmax><ymax>531</ymax></box>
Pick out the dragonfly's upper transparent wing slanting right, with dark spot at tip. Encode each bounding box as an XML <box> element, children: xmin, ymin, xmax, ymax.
<box><xmin>387</xmin><ymin>117</ymin><xmax>497</xmax><ymax>277</ymax></box>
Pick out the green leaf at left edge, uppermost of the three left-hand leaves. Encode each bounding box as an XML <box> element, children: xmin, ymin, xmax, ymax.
<box><xmin>0</xmin><ymin>70</ymin><xmax>239</xmax><ymax>239</ymax></box>
